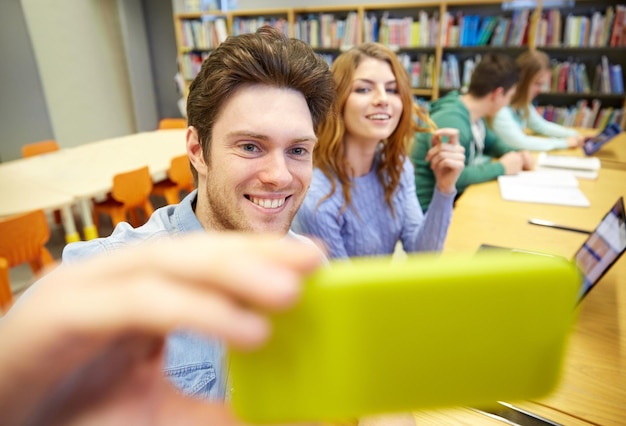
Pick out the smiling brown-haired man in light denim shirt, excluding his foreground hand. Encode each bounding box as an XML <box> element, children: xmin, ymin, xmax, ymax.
<box><xmin>63</xmin><ymin>27</ymin><xmax>335</xmax><ymax>399</ymax></box>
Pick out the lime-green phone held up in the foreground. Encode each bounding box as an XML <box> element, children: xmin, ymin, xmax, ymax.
<box><xmin>229</xmin><ymin>253</ymin><xmax>580</xmax><ymax>423</ymax></box>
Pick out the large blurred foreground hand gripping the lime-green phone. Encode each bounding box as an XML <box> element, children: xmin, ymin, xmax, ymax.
<box><xmin>0</xmin><ymin>233</ymin><xmax>321</xmax><ymax>426</ymax></box>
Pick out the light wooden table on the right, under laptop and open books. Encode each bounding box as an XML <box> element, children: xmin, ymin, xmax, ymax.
<box><xmin>416</xmin><ymin>168</ymin><xmax>626</xmax><ymax>425</ymax></box>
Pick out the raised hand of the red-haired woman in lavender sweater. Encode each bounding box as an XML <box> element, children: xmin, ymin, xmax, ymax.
<box><xmin>426</xmin><ymin>128</ymin><xmax>465</xmax><ymax>194</ymax></box>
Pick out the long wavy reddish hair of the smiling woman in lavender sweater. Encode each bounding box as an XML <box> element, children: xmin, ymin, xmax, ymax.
<box><xmin>313</xmin><ymin>43</ymin><xmax>434</xmax><ymax>213</ymax></box>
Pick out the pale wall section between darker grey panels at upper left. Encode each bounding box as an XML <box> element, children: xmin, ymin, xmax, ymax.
<box><xmin>21</xmin><ymin>0</ymin><xmax>136</xmax><ymax>147</ymax></box>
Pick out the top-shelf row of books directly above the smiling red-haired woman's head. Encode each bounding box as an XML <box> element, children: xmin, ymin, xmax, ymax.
<box><xmin>363</xmin><ymin>10</ymin><xmax>439</xmax><ymax>47</ymax></box>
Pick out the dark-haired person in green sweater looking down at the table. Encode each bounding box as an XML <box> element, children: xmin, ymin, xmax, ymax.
<box><xmin>411</xmin><ymin>53</ymin><xmax>533</xmax><ymax>212</ymax></box>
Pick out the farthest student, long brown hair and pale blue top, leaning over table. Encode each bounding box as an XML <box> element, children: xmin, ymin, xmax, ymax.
<box><xmin>492</xmin><ymin>50</ymin><xmax>584</xmax><ymax>151</ymax></box>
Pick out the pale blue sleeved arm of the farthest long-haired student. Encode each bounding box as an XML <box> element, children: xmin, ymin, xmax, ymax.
<box><xmin>493</xmin><ymin>107</ymin><xmax>568</xmax><ymax>151</ymax></box>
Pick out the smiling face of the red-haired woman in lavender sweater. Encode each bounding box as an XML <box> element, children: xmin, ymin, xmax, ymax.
<box><xmin>343</xmin><ymin>58</ymin><xmax>403</xmax><ymax>143</ymax></box>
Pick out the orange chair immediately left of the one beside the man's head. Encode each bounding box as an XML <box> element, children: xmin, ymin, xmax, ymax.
<box><xmin>93</xmin><ymin>166</ymin><xmax>154</xmax><ymax>227</ymax></box>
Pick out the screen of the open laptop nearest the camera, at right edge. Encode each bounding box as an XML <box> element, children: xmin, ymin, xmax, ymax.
<box><xmin>574</xmin><ymin>197</ymin><xmax>626</xmax><ymax>298</ymax></box>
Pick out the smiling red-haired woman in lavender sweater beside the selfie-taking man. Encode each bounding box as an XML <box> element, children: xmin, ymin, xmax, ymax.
<box><xmin>292</xmin><ymin>43</ymin><xmax>465</xmax><ymax>258</ymax></box>
